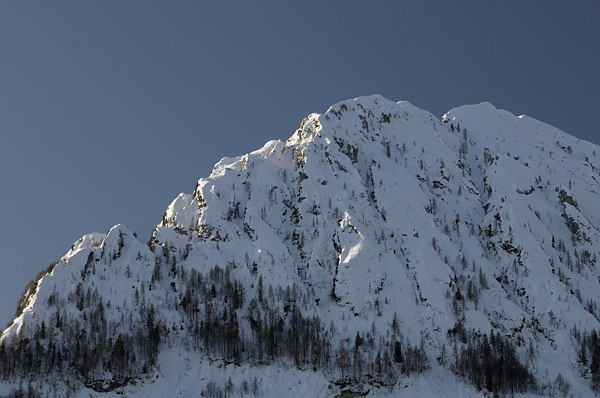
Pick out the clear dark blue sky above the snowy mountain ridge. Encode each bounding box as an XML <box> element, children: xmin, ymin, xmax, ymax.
<box><xmin>0</xmin><ymin>0</ymin><xmax>600</xmax><ymax>325</ymax></box>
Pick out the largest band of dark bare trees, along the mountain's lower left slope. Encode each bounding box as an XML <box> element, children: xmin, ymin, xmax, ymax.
<box><xmin>0</xmin><ymin>251</ymin><xmax>429</xmax><ymax>396</ymax></box>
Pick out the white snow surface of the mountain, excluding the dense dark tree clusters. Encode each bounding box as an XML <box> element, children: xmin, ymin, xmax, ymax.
<box><xmin>0</xmin><ymin>95</ymin><xmax>600</xmax><ymax>398</ymax></box>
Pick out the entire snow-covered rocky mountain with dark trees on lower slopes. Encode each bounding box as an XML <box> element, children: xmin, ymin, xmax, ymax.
<box><xmin>0</xmin><ymin>95</ymin><xmax>600</xmax><ymax>397</ymax></box>
